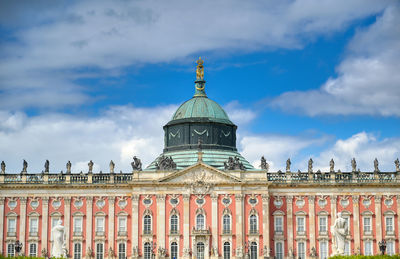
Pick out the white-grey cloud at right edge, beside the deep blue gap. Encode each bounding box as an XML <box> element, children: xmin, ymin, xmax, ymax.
<box><xmin>272</xmin><ymin>7</ymin><xmax>400</xmax><ymax>116</ymax></box>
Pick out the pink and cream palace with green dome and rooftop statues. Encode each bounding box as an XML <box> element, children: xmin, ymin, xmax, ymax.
<box><xmin>0</xmin><ymin>59</ymin><xmax>400</xmax><ymax>259</ymax></box>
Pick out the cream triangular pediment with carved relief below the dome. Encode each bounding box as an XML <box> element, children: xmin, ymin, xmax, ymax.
<box><xmin>159</xmin><ymin>162</ymin><xmax>241</xmax><ymax>184</ymax></box>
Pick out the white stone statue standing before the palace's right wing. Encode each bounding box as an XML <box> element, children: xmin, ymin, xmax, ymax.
<box><xmin>331</xmin><ymin>212</ymin><xmax>348</xmax><ymax>256</ymax></box>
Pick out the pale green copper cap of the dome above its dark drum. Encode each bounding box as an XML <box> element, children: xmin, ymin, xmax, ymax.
<box><xmin>172</xmin><ymin>95</ymin><xmax>233</xmax><ymax>124</ymax></box>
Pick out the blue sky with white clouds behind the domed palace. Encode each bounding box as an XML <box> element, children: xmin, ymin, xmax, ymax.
<box><xmin>0</xmin><ymin>0</ymin><xmax>400</xmax><ymax>173</ymax></box>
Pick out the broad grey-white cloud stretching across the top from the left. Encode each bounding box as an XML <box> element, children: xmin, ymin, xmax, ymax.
<box><xmin>0</xmin><ymin>0</ymin><xmax>391</xmax><ymax>109</ymax></box>
